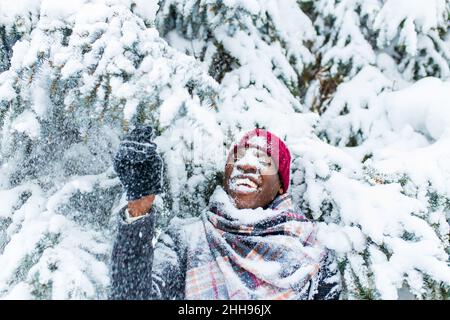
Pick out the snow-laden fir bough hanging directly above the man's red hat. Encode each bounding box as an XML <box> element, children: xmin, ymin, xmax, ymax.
<box><xmin>157</xmin><ymin>0</ymin><xmax>317</xmax><ymax>137</ymax></box>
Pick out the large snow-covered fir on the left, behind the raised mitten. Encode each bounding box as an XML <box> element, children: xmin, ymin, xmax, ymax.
<box><xmin>0</xmin><ymin>0</ymin><xmax>220</xmax><ymax>299</ymax></box>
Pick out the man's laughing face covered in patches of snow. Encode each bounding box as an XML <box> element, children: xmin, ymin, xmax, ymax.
<box><xmin>224</xmin><ymin>147</ymin><xmax>283</xmax><ymax>209</ymax></box>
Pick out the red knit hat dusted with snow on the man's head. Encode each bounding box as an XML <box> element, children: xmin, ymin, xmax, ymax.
<box><xmin>234</xmin><ymin>128</ymin><xmax>291</xmax><ymax>192</ymax></box>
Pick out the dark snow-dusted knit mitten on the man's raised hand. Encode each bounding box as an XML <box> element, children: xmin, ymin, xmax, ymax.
<box><xmin>113</xmin><ymin>126</ymin><xmax>163</xmax><ymax>205</ymax></box>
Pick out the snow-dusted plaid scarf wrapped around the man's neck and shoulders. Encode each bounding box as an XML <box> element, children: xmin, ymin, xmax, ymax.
<box><xmin>185</xmin><ymin>188</ymin><xmax>325</xmax><ymax>300</ymax></box>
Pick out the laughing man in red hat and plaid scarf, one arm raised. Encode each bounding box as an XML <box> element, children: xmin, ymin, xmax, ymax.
<box><xmin>111</xmin><ymin>127</ymin><xmax>340</xmax><ymax>299</ymax></box>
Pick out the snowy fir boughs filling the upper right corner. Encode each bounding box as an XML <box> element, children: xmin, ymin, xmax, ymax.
<box><xmin>301</xmin><ymin>0</ymin><xmax>450</xmax><ymax>112</ymax></box>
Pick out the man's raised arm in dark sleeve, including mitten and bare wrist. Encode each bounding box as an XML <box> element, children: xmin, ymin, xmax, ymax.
<box><xmin>111</xmin><ymin>126</ymin><xmax>163</xmax><ymax>299</ymax></box>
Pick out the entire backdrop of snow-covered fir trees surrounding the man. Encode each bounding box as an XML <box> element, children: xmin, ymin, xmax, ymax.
<box><xmin>0</xmin><ymin>0</ymin><xmax>450</xmax><ymax>299</ymax></box>
